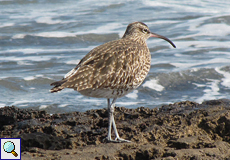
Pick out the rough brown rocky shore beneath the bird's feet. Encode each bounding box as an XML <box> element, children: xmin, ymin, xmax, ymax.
<box><xmin>0</xmin><ymin>99</ymin><xmax>230</xmax><ymax>160</ymax></box>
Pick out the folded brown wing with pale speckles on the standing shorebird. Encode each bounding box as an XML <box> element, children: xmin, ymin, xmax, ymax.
<box><xmin>61</xmin><ymin>40</ymin><xmax>146</xmax><ymax>91</ymax></box>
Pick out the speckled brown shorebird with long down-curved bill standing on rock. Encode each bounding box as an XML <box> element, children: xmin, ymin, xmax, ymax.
<box><xmin>50</xmin><ymin>22</ymin><xmax>176</xmax><ymax>142</ymax></box>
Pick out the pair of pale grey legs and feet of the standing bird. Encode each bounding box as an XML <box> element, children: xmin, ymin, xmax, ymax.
<box><xmin>107</xmin><ymin>98</ymin><xmax>131</xmax><ymax>142</ymax></box>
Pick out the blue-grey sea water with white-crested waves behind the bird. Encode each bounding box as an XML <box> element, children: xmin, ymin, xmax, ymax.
<box><xmin>0</xmin><ymin>0</ymin><xmax>230</xmax><ymax>113</ymax></box>
